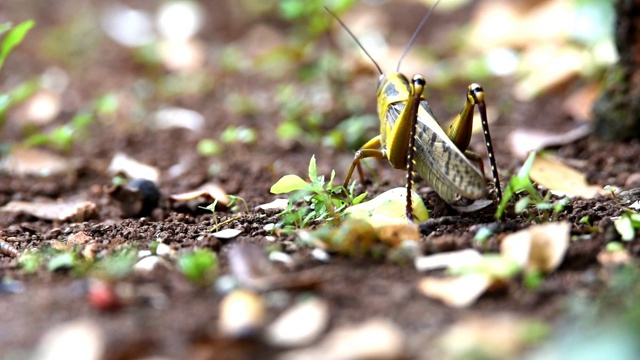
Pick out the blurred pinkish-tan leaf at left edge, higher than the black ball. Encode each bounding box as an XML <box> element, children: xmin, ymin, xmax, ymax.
<box><xmin>0</xmin><ymin>146</ymin><xmax>74</xmax><ymax>176</ymax></box>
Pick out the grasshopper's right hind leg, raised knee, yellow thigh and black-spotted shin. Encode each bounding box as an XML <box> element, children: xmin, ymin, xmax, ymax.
<box><xmin>447</xmin><ymin>83</ymin><xmax>502</xmax><ymax>202</ymax></box>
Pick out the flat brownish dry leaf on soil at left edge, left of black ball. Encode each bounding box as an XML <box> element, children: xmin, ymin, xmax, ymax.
<box><xmin>0</xmin><ymin>200</ymin><xmax>98</xmax><ymax>222</ymax></box>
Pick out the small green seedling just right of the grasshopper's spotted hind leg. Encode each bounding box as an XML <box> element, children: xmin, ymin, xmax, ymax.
<box><xmin>495</xmin><ymin>152</ymin><xmax>570</xmax><ymax>221</ymax></box>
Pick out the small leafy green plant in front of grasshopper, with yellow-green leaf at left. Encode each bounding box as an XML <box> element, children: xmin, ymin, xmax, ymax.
<box><xmin>271</xmin><ymin>156</ymin><xmax>367</xmax><ymax>228</ymax></box>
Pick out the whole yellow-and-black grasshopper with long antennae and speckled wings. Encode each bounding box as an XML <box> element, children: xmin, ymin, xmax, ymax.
<box><xmin>327</xmin><ymin>2</ymin><xmax>502</xmax><ymax>221</ymax></box>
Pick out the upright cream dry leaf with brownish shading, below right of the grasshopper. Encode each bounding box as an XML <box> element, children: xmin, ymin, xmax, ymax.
<box><xmin>500</xmin><ymin>221</ymin><xmax>571</xmax><ymax>273</ymax></box>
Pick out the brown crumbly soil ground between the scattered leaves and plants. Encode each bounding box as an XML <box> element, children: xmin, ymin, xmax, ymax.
<box><xmin>0</xmin><ymin>0</ymin><xmax>640</xmax><ymax>359</ymax></box>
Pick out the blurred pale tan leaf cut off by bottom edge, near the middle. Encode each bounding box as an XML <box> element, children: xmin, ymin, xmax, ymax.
<box><xmin>280</xmin><ymin>318</ymin><xmax>406</xmax><ymax>360</ymax></box>
